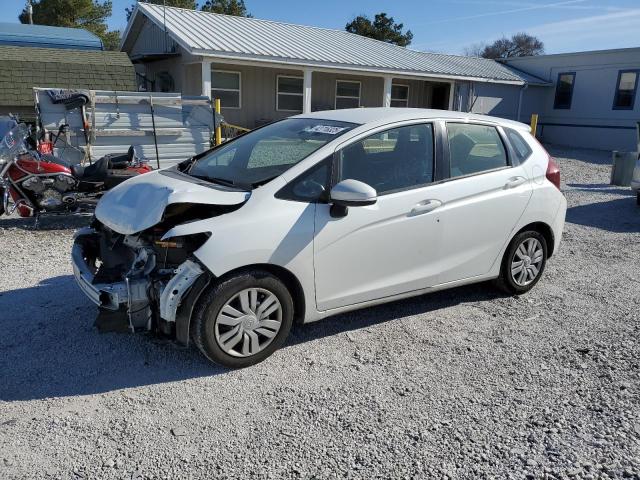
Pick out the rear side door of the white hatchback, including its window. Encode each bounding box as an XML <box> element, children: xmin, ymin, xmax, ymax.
<box><xmin>438</xmin><ymin>122</ymin><xmax>532</xmax><ymax>283</ymax></box>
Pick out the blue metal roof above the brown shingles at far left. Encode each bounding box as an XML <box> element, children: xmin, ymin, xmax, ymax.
<box><xmin>0</xmin><ymin>22</ymin><xmax>103</xmax><ymax>50</ymax></box>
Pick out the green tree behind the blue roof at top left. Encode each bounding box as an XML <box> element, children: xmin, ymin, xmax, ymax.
<box><xmin>18</xmin><ymin>0</ymin><xmax>120</xmax><ymax>50</ymax></box>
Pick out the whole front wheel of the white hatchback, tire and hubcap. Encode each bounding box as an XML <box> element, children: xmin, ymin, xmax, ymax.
<box><xmin>192</xmin><ymin>270</ymin><xmax>293</xmax><ymax>368</ymax></box>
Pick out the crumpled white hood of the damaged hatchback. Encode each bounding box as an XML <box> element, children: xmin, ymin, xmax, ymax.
<box><xmin>95</xmin><ymin>169</ymin><xmax>251</xmax><ymax>235</ymax></box>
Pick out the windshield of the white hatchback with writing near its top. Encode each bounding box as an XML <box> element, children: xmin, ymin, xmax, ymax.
<box><xmin>186</xmin><ymin>118</ymin><xmax>357</xmax><ymax>188</ymax></box>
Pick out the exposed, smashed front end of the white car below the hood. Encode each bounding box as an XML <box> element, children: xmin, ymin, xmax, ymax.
<box><xmin>72</xmin><ymin>221</ymin><xmax>209</xmax><ymax>338</ymax></box>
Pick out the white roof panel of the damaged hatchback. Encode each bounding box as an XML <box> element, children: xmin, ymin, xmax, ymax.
<box><xmin>297</xmin><ymin>107</ymin><xmax>529</xmax><ymax>130</ymax></box>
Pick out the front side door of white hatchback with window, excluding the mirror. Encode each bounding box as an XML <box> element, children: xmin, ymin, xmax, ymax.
<box><xmin>314</xmin><ymin>123</ymin><xmax>440</xmax><ymax>311</ymax></box>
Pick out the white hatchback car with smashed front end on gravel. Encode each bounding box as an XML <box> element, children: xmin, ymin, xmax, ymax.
<box><xmin>72</xmin><ymin>108</ymin><xmax>566</xmax><ymax>367</ymax></box>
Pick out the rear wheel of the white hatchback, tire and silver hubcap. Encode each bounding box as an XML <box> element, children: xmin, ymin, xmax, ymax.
<box><xmin>496</xmin><ymin>230</ymin><xmax>547</xmax><ymax>295</ymax></box>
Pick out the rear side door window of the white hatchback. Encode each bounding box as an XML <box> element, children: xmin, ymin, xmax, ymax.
<box><xmin>447</xmin><ymin>123</ymin><xmax>509</xmax><ymax>178</ymax></box>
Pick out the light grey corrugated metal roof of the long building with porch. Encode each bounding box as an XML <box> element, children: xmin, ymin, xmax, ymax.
<box><xmin>123</xmin><ymin>3</ymin><xmax>546</xmax><ymax>84</ymax></box>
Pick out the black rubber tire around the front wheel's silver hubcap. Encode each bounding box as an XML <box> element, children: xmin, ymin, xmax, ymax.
<box><xmin>191</xmin><ymin>270</ymin><xmax>294</xmax><ymax>368</ymax></box>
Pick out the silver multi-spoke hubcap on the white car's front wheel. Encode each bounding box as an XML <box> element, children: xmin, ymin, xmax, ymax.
<box><xmin>214</xmin><ymin>288</ymin><xmax>282</xmax><ymax>357</ymax></box>
